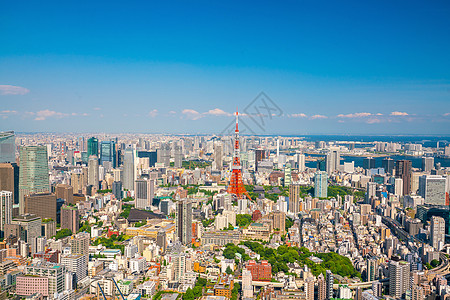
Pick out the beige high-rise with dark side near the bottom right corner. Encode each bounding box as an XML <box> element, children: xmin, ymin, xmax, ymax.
<box><xmin>389</xmin><ymin>260</ymin><xmax>411</xmax><ymax>299</ymax></box>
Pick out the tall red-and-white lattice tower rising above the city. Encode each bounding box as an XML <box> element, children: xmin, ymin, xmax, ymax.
<box><xmin>227</xmin><ymin>111</ymin><xmax>252</xmax><ymax>200</ymax></box>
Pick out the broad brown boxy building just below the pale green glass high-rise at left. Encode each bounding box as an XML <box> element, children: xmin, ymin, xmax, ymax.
<box><xmin>24</xmin><ymin>193</ymin><xmax>57</xmax><ymax>221</ymax></box>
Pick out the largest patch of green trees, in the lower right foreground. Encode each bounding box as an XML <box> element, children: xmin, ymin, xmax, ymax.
<box><xmin>223</xmin><ymin>241</ymin><xmax>361</xmax><ymax>278</ymax></box>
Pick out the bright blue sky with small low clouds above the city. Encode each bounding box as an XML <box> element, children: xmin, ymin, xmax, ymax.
<box><xmin>0</xmin><ymin>1</ymin><xmax>450</xmax><ymax>135</ymax></box>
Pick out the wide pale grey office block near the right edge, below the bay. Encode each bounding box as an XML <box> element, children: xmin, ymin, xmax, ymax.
<box><xmin>418</xmin><ymin>175</ymin><xmax>447</xmax><ymax>205</ymax></box>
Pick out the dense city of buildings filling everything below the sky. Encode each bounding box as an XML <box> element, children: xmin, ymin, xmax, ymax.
<box><xmin>0</xmin><ymin>113</ymin><xmax>450</xmax><ymax>300</ymax></box>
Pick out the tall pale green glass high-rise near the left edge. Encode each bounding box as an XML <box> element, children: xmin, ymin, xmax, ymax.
<box><xmin>19</xmin><ymin>146</ymin><xmax>50</xmax><ymax>214</ymax></box>
